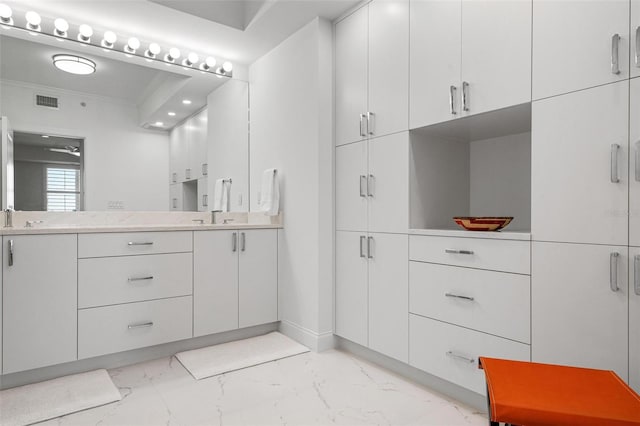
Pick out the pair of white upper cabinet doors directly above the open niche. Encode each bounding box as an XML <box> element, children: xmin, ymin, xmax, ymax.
<box><xmin>410</xmin><ymin>0</ymin><xmax>531</xmax><ymax>129</ymax></box>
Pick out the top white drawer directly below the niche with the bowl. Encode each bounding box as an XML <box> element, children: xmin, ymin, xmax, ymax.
<box><xmin>409</xmin><ymin>235</ymin><xmax>531</xmax><ymax>274</ymax></box>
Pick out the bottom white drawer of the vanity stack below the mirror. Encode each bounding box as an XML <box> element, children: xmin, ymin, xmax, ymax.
<box><xmin>78</xmin><ymin>296</ymin><xmax>193</xmax><ymax>359</ymax></box>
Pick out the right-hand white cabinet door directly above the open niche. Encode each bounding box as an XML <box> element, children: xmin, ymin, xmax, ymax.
<box><xmin>461</xmin><ymin>0</ymin><xmax>531</xmax><ymax>114</ymax></box>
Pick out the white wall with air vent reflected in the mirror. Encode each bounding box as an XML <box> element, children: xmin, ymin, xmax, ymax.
<box><xmin>0</xmin><ymin>81</ymin><xmax>169</xmax><ymax>210</ymax></box>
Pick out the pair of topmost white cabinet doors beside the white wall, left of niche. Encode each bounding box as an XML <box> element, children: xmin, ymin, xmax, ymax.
<box><xmin>335</xmin><ymin>0</ymin><xmax>409</xmax><ymax>145</ymax></box>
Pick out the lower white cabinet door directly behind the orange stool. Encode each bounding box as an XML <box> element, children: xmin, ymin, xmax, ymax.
<box><xmin>531</xmin><ymin>242</ymin><xmax>629</xmax><ymax>381</ymax></box>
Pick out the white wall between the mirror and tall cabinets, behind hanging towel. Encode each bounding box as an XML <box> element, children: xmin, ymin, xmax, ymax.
<box><xmin>249</xmin><ymin>19</ymin><xmax>333</xmax><ymax>346</ymax></box>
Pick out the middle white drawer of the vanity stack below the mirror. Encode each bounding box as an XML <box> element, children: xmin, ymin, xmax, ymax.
<box><xmin>78</xmin><ymin>253</ymin><xmax>193</xmax><ymax>308</ymax></box>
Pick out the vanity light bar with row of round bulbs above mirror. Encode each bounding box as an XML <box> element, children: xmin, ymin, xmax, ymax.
<box><xmin>0</xmin><ymin>3</ymin><xmax>233</xmax><ymax>77</ymax></box>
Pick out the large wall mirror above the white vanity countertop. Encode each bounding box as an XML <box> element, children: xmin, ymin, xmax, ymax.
<box><xmin>0</xmin><ymin>30</ymin><xmax>249</xmax><ymax>211</ymax></box>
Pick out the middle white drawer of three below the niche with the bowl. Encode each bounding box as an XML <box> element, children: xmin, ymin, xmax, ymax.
<box><xmin>409</xmin><ymin>262</ymin><xmax>531</xmax><ymax>343</ymax></box>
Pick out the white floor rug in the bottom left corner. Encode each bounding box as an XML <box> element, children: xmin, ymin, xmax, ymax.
<box><xmin>0</xmin><ymin>370</ymin><xmax>122</xmax><ymax>426</ymax></box>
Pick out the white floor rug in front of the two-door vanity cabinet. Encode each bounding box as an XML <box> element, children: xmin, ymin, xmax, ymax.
<box><xmin>176</xmin><ymin>331</ymin><xmax>309</xmax><ymax>380</ymax></box>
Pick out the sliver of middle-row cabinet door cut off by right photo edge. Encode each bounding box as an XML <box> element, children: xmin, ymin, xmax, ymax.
<box><xmin>629</xmin><ymin>77</ymin><xmax>640</xmax><ymax>246</ymax></box>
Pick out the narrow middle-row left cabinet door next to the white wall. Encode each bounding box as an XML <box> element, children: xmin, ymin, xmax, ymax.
<box><xmin>336</xmin><ymin>141</ymin><xmax>368</xmax><ymax>232</ymax></box>
